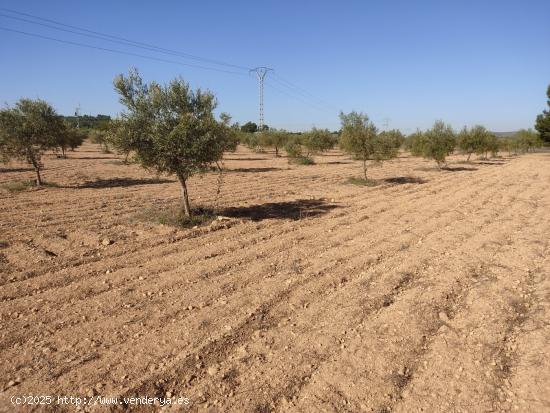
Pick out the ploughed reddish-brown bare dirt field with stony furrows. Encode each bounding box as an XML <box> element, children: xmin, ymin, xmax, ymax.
<box><xmin>0</xmin><ymin>144</ymin><xmax>550</xmax><ymax>413</ymax></box>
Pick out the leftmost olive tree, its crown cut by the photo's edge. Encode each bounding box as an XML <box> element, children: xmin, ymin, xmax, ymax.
<box><xmin>0</xmin><ymin>99</ymin><xmax>66</xmax><ymax>186</ymax></box>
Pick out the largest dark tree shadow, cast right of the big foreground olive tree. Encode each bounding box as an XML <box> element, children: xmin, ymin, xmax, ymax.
<box><xmin>219</xmin><ymin>199</ymin><xmax>338</xmax><ymax>221</ymax></box>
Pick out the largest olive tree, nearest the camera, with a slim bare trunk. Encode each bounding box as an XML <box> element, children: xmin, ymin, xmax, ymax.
<box><xmin>111</xmin><ymin>69</ymin><xmax>237</xmax><ymax>217</ymax></box>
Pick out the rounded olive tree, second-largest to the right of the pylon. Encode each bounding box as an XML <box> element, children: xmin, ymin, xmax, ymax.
<box><xmin>411</xmin><ymin>120</ymin><xmax>456</xmax><ymax>169</ymax></box>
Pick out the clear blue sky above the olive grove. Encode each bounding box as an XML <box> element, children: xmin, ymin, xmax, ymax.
<box><xmin>0</xmin><ymin>0</ymin><xmax>550</xmax><ymax>133</ymax></box>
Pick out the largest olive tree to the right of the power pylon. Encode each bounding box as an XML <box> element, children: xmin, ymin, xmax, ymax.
<box><xmin>340</xmin><ymin>112</ymin><xmax>399</xmax><ymax>180</ymax></box>
